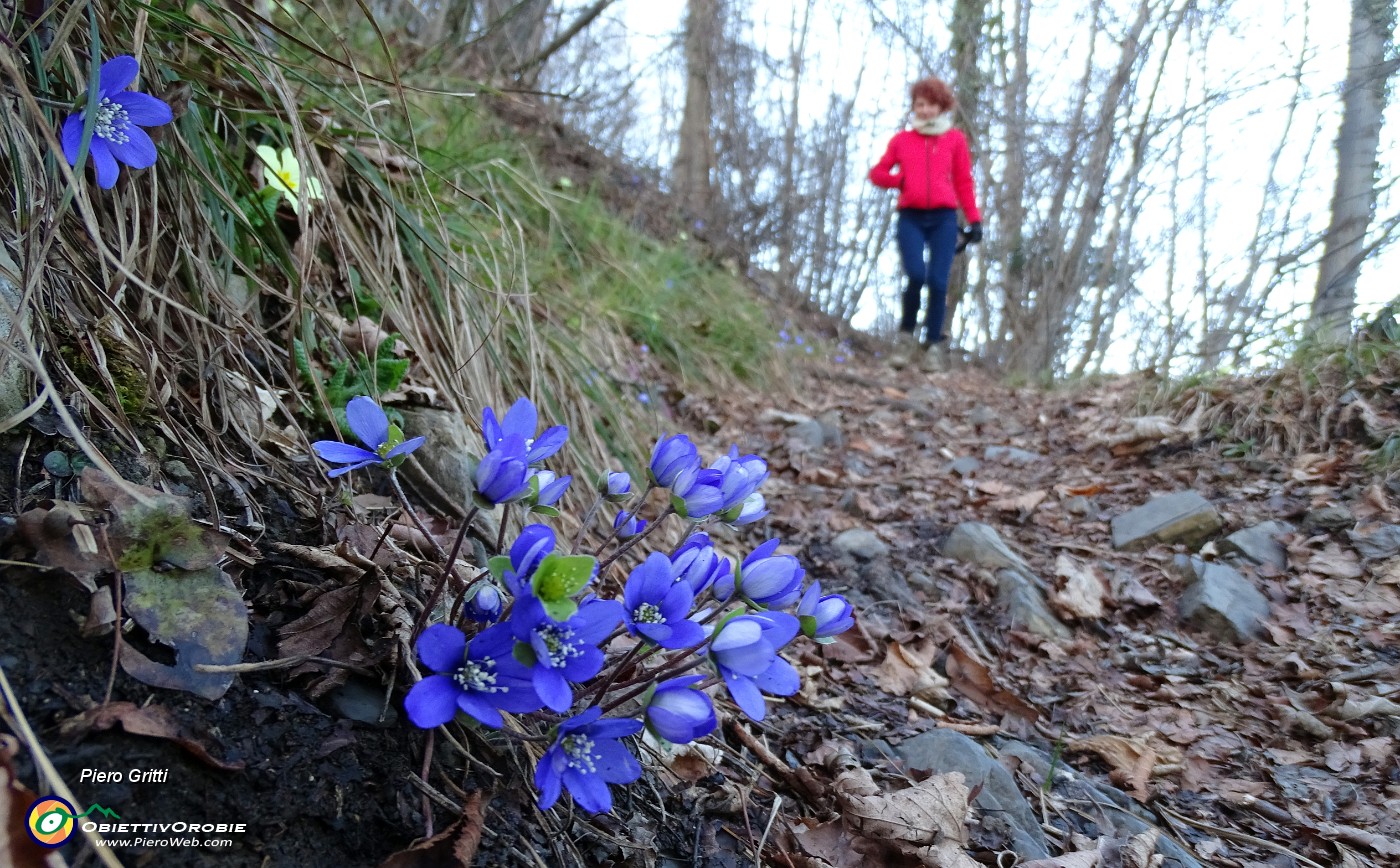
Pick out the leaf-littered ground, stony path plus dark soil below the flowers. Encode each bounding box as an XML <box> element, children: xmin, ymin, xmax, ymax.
<box><xmin>0</xmin><ymin>353</ymin><xmax>1400</xmax><ymax>868</ymax></box>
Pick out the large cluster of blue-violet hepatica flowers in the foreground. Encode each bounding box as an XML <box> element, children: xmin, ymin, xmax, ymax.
<box><xmin>314</xmin><ymin>398</ymin><xmax>854</xmax><ymax>812</ymax></box>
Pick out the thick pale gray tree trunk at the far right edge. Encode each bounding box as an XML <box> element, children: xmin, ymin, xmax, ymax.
<box><xmin>1308</xmin><ymin>0</ymin><xmax>1396</xmax><ymax>343</ymax></box>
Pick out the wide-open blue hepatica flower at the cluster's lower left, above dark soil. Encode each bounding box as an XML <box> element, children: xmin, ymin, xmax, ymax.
<box><xmin>403</xmin><ymin>624</ymin><xmax>543</xmax><ymax>729</ymax></box>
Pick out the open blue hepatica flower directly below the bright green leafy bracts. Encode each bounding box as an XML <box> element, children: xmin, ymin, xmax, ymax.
<box><xmin>507</xmin><ymin>596</ymin><xmax>623</xmax><ymax>711</ymax></box>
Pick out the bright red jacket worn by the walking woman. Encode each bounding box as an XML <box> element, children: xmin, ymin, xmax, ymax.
<box><xmin>871</xmin><ymin>129</ymin><xmax>981</xmax><ymax>223</ymax></box>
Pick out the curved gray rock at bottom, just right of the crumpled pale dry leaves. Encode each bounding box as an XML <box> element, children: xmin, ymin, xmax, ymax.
<box><xmin>895</xmin><ymin>729</ymin><xmax>1050</xmax><ymax>860</ymax></box>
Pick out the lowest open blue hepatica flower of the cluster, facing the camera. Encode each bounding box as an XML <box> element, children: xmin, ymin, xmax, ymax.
<box><xmin>535</xmin><ymin>706</ymin><xmax>641</xmax><ymax>813</ymax></box>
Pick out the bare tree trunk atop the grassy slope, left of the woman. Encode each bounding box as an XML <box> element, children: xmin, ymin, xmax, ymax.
<box><xmin>672</xmin><ymin>0</ymin><xmax>724</xmax><ymax>220</ymax></box>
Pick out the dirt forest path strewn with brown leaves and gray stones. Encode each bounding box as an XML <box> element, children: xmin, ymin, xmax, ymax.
<box><xmin>672</xmin><ymin>348</ymin><xmax>1400</xmax><ymax>867</ymax></box>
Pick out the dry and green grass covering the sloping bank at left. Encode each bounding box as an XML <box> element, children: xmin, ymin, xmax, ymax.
<box><xmin>0</xmin><ymin>3</ymin><xmax>773</xmax><ymax>524</ymax></box>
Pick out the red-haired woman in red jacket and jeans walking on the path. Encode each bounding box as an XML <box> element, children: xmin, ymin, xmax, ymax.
<box><xmin>871</xmin><ymin>78</ymin><xmax>981</xmax><ymax>371</ymax></box>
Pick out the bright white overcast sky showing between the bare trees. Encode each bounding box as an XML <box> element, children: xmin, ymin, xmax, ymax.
<box><xmin>588</xmin><ymin>0</ymin><xmax>1400</xmax><ymax>345</ymax></box>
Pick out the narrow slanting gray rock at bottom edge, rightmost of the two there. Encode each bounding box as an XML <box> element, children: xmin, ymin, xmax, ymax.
<box><xmin>997</xmin><ymin>739</ymin><xmax>1204</xmax><ymax>868</ymax></box>
